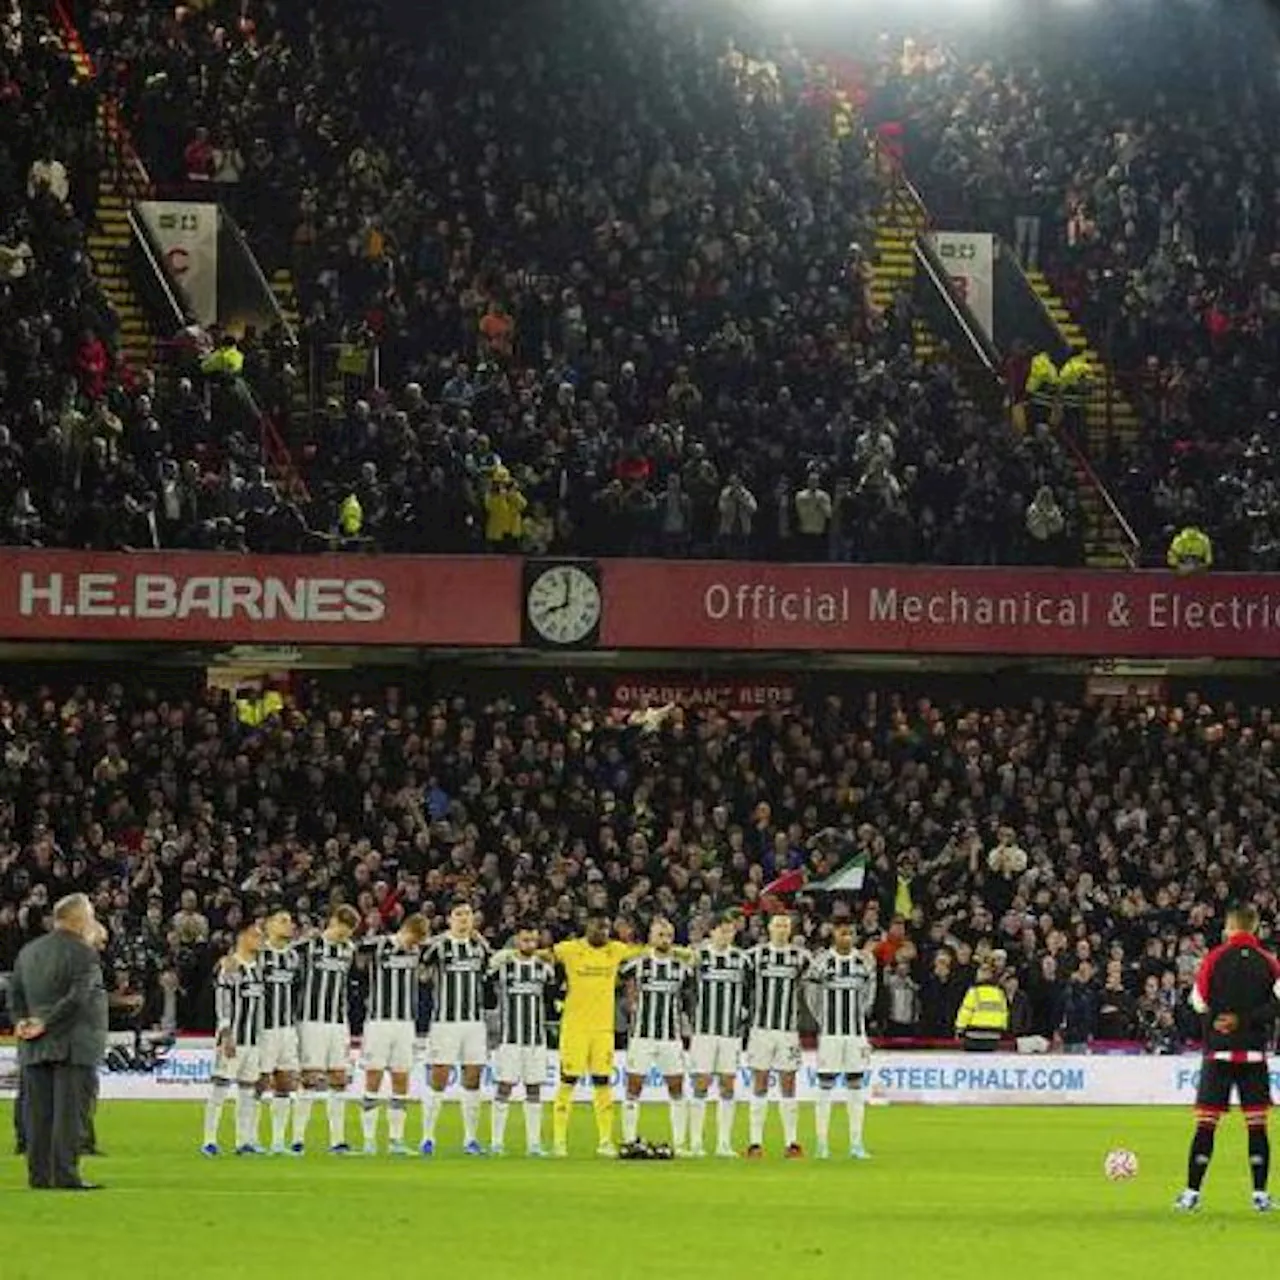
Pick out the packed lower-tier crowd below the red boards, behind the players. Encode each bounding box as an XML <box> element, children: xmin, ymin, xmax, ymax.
<box><xmin>0</xmin><ymin>684</ymin><xmax>1264</xmax><ymax>1051</ymax></box>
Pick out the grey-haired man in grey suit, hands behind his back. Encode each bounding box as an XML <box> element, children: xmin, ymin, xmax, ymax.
<box><xmin>9</xmin><ymin>893</ymin><xmax>108</xmax><ymax>1190</ymax></box>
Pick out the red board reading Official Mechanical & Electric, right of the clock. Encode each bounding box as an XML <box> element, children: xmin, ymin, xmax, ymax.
<box><xmin>600</xmin><ymin>561</ymin><xmax>1280</xmax><ymax>658</ymax></box>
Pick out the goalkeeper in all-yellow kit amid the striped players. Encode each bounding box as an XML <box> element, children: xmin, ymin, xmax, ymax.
<box><xmin>550</xmin><ymin>911</ymin><xmax>644</xmax><ymax>1156</ymax></box>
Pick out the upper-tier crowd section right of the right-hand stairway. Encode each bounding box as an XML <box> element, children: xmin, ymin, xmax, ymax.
<box><xmin>870</xmin><ymin>4</ymin><xmax>1280</xmax><ymax>570</ymax></box>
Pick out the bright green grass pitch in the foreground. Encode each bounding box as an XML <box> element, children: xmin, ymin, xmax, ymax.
<box><xmin>0</xmin><ymin>1102</ymin><xmax>1280</xmax><ymax>1280</ymax></box>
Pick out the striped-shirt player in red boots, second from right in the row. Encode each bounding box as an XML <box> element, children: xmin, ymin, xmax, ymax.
<box><xmin>746</xmin><ymin>914</ymin><xmax>809</xmax><ymax>1160</ymax></box>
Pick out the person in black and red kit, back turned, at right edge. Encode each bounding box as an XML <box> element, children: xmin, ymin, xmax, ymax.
<box><xmin>1174</xmin><ymin>906</ymin><xmax>1280</xmax><ymax>1213</ymax></box>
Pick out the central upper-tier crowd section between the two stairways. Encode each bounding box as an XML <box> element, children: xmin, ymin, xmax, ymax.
<box><xmin>32</xmin><ymin>0</ymin><xmax>1080</xmax><ymax>563</ymax></box>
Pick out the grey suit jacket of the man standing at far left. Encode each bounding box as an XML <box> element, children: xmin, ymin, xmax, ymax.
<box><xmin>9</xmin><ymin>929</ymin><xmax>108</xmax><ymax>1066</ymax></box>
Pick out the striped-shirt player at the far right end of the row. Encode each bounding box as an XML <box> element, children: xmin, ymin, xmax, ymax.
<box><xmin>809</xmin><ymin>920</ymin><xmax>877</xmax><ymax>1160</ymax></box>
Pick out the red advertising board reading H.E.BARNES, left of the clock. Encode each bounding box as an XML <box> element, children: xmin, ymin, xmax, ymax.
<box><xmin>0</xmin><ymin>550</ymin><xmax>520</xmax><ymax>646</ymax></box>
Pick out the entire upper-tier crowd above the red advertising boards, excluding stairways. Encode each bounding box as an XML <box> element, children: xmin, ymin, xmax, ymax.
<box><xmin>0</xmin><ymin>0</ymin><xmax>1280</xmax><ymax>568</ymax></box>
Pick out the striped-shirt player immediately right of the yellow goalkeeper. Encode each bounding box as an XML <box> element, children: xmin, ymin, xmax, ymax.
<box><xmin>618</xmin><ymin>918</ymin><xmax>690</xmax><ymax>1155</ymax></box>
